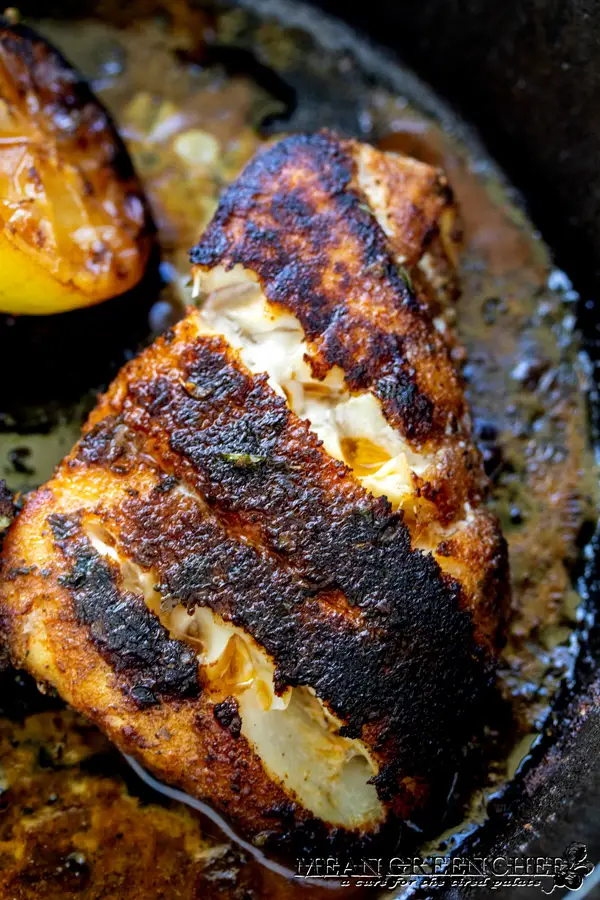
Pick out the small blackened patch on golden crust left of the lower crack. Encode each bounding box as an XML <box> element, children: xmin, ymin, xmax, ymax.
<box><xmin>48</xmin><ymin>515</ymin><xmax>199</xmax><ymax>707</ymax></box>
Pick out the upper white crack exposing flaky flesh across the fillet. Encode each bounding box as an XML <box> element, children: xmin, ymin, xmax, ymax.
<box><xmin>194</xmin><ymin>265</ymin><xmax>472</xmax><ymax>576</ymax></box>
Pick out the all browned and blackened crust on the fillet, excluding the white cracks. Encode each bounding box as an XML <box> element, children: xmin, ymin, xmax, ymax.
<box><xmin>0</xmin><ymin>137</ymin><xmax>506</xmax><ymax>847</ymax></box>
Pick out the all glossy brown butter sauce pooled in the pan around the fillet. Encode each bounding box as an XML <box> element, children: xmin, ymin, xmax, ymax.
<box><xmin>0</xmin><ymin>3</ymin><xmax>596</xmax><ymax>900</ymax></box>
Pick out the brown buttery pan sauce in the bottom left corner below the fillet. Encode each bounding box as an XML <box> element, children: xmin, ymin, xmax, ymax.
<box><xmin>0</xmin><ymin>673</ymin><xmax>338</xmax><ymax>900</ymax></box>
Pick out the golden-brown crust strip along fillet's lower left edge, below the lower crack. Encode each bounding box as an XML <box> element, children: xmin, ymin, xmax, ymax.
<box><xmin>3</xmin><ymin>474</ymin><xmax>322</xmax><ymax>848</ymax></box>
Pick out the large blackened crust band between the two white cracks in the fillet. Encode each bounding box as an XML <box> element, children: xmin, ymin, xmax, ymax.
<box><xmin>96</xmin><ymin>337</ymin><xmax>490</xmax><ymax>796</ymax></box>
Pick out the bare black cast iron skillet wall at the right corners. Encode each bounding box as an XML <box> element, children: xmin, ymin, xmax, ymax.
<box><xmin>4</xmin><ymin>0</ymin><xmax>600</xmax><ymax>898</ymax></box>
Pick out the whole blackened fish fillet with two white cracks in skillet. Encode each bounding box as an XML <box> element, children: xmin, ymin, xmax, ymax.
<box><xmin>0</xmin><ymin>133</ymin><xmax>508</xmax><ymax>849</ymax></box>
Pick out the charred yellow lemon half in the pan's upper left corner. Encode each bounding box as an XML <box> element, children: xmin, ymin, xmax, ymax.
<box><xmin>0</xmin><ymin>19</ymin><xmax>152</xmax><ymax>315</ymax></box>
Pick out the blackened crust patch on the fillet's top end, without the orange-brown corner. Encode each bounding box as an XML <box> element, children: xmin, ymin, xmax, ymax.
<box><xmin>190</xmin><ymin>133</ymin><xmax>462</xmax><ymax>444</ymax></box>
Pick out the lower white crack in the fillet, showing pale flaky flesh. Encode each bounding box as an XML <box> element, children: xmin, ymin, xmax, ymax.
<box><xmin>83</xmin><ymin>512</ymin><xmax>384</xmax><ymax>828</ymax></box>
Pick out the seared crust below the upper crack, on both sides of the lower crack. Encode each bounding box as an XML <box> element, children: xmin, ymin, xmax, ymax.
<box><xmin>0</xmin><ymin>313</ymin><xmax>502</xmax><ymax>852</ymax></box>
